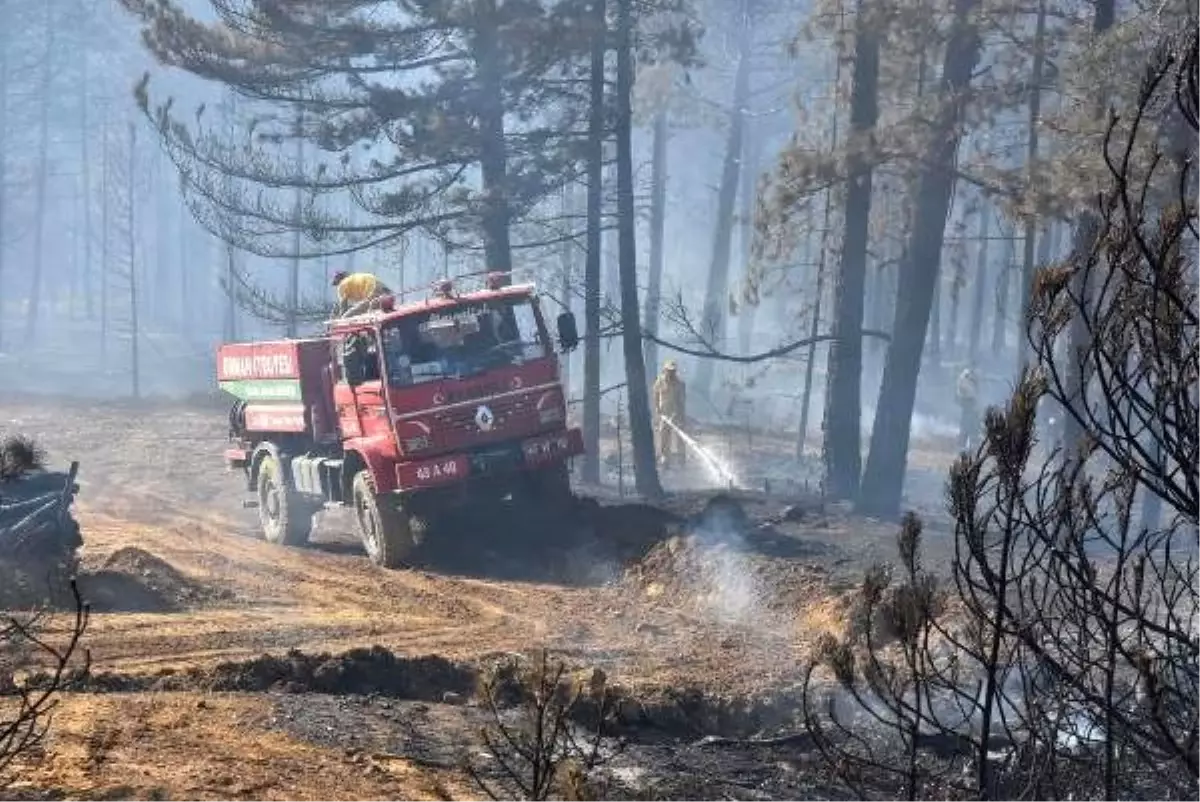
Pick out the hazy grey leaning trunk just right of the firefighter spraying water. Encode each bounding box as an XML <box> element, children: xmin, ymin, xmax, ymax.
<box><xmin>692</xmin><ymin>1</ymin><xmax>750</xmax><ymax>408</ymax></box>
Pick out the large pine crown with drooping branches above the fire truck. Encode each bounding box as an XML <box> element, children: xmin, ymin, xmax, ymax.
<box><xmin>122</xmin><ymin>0</ymin><xmax>600</xmax><ymax>271</ymax></box>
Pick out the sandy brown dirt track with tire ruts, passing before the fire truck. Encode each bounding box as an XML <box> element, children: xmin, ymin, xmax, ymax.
<box><xmin>0</xmin><ymin>402</ymin><xmax>849</xmax><ymax>693</ymax></box>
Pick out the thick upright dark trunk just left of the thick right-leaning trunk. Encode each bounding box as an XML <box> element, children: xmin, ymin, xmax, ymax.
<box><xmin>822</xmin><ymin>0</ymin><xmax>880</xmax><ymax>499</ymax></box>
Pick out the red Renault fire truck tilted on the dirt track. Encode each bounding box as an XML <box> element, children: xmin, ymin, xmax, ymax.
<box><xmin>217</xmin><ymin>274</ymin><xmax>583</xmax><ymax>568</ymax></box>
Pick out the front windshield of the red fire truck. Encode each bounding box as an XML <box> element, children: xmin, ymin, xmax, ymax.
<box><xmin>383</xmin><ymin>298</ymin><xmax>547</xmax><ymax>387</ymax></box>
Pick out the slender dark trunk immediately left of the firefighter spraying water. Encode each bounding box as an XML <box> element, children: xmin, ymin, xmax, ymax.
<box><xmin>616</xmin><ymin>0</ymin><xmax>662</xmax><ymax>499</ymax></box>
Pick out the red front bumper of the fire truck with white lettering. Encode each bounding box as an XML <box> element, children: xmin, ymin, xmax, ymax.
<box><xmin>396</xmin><ymin>429</ymin><xmax>583</xmax><ymax>492</ymax></box>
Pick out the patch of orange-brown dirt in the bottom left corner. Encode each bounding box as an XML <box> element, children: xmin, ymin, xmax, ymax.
<box><xmin>12</xmin><ymin>694</ymin><xmax>475</xmax><ymax>802</ymax></box>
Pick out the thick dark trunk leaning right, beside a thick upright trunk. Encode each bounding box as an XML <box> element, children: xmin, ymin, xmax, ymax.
<box><xmin>858</xmin><ymin>0</ymin><xmax>982</xmax><ymax>515</ymax></box>
